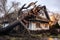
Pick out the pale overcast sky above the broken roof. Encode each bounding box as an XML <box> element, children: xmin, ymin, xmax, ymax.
<box><xmin>8</xmin><ymin>0</ymin><xmax>60</xmax><ymax>12</ymax></box>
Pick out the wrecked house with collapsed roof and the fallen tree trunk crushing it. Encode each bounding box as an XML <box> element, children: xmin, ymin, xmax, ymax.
<box><xmin>0</xmin><ymin>2</ymin><xmax>59</xmax><ymax>33</ymax></box>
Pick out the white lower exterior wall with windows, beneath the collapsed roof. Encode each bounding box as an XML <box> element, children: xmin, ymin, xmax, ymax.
<box><xmin>28</xmin><ymin>22</ymin><xmax>49</xmax><ymax>30</ymax></box>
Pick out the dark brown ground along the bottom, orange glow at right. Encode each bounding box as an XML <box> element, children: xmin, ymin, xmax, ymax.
<box><xmin>0</xmin><ymin>34</ymin><xmax>60</xmax><ymax>40</ymax></box>
